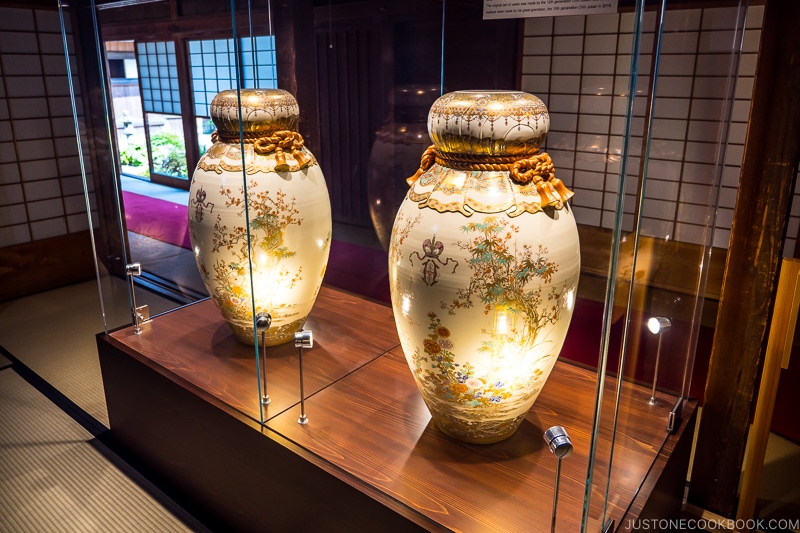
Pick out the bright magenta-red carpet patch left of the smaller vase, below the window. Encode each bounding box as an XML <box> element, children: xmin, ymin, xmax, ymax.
<box><xmin>122</xmin><ymin>191</ymin><xmax>192</xmax><ymax>250</ymax></box>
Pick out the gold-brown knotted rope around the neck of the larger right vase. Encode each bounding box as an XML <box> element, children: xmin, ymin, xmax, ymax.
<box><xmin>406</xmin><ymin>145</ymin><xmax>574</xmax><ymax>207</ymax></box>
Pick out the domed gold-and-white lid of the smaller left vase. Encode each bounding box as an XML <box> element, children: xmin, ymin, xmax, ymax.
<box><xmin>211</xmin><ymin>89</ymin><xmax>300</xmax><ymax>139</ymax></box>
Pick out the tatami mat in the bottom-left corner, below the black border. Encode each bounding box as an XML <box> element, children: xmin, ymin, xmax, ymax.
<box><xmin>0</xmin><ymin>367</ymin><xmax>199</xmax><ymax>533</ymax></box>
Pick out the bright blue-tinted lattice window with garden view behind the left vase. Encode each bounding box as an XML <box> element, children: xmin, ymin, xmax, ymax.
<box><xmin>106</xmin><ymin>35</ymin><xmax>277</xmax><ymax>188</ymax></box>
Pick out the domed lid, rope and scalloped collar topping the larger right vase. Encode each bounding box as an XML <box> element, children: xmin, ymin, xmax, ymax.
<box><xmin>407</xmin><ymin>91</ymin><xmax>573</xmax><ymax>217</ymax></box>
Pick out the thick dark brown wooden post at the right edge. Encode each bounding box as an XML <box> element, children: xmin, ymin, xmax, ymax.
<box><xmin>689</xmin><ymin>0</ymin><xmax>800</xmax><ymax>517</ymax></box>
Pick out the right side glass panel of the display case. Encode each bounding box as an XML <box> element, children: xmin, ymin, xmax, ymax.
<box><xmin>576</xmin><ymin>6</ymin><xmax>749</xmax><ymax>521</ymax></box>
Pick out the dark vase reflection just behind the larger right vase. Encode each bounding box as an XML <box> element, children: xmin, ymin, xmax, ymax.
<box><xmin>367</xmin><ymin>85</ymin><xmax>439</xmax><ymax>249</ymax></box>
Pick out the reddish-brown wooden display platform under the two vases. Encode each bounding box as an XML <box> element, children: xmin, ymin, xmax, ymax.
<box><xmin>98</xmin><ymin>288</ymin><xmax>695</xmax><ymax>532</ymax></box>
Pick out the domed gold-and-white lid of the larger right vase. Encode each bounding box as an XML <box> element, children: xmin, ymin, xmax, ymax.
<box><xmin>428</xmin><ymin>91</ymin><xmax>550</xmax><ymax>156</ymax></box>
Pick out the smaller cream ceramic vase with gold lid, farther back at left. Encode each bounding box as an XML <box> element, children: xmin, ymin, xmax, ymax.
<box><xmin>189</xmin><ymin>89</ymin><xmax>331</xmax><ymax>345</ymax></box>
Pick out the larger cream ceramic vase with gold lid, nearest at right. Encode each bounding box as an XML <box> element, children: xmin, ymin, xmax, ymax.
<box><xmin>389</xmin><ymin>91</ymin><xmax>580</xmax><ymax>443</ymax></box>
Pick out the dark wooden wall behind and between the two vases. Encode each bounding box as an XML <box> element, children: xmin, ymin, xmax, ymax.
<box><xmin>314</xmin><ymin>0</ymin><xmax>519</xmax><ymax>227</ymax></box>
